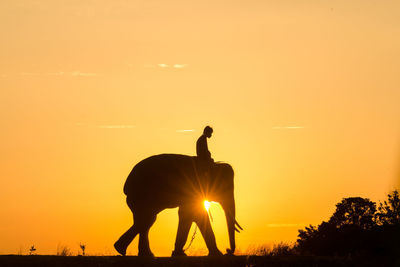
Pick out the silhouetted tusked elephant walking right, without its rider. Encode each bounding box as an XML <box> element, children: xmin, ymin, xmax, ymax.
<box><xmin>114</xmin><ymin>154</ymin><xmax>243</xmax><ymax>257</ymax></box>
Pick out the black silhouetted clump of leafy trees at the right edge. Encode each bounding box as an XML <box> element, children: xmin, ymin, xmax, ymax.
<box><xmin>296</xmin><ymin>190</ymin><xmax>400</xmax><ymax>258</ymax></box>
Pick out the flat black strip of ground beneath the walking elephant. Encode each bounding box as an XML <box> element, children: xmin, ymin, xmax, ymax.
<box><xmin>0</xmin><ymin>255</ymin><xmax>400</xmax><ymax>267</ymax></box>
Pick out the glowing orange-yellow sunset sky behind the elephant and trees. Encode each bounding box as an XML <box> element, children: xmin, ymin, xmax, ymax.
<box><xmin>0</xmin><ymin>0</ymin><xmax>400</xmax><ymax>256</ymax></box>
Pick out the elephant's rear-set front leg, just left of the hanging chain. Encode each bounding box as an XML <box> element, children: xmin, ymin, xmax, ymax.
<box><xmin>172</xmin><ymin>208</ymin><xmax>193</xmax><ymax>257</ymax></box>
